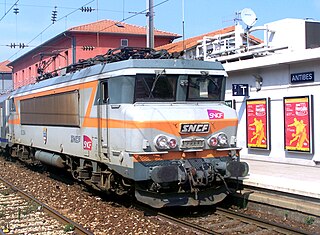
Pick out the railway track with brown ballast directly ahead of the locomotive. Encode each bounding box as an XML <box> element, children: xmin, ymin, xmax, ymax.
<box><xmin>147</xmin><ymin>208</ymin><xmax>312</xmax><ymax>235</ymax></box>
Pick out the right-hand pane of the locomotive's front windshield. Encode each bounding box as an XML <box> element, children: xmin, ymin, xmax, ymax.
<box><xmin>187</xmin><ymin>75</ymin><xmax>225</xmax><ymax>101</ymax></box>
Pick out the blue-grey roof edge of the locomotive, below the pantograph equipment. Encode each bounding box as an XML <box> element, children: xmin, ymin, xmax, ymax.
<box><xmin>12</xmin><ymin>59</ymin><xmax>224</xmax><ymax>95</ymax></box>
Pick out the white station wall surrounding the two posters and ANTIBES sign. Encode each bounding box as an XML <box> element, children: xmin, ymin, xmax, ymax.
<box><xmin>226</xmin><ymin>58</ymin><xmax>320</xmax><ymax>166</ymax></box>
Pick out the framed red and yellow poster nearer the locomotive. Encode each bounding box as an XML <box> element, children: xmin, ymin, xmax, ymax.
<box><xmin>246</xmin><ymin>99</ymin><xmax>270</xmax><ymax>150</ymax></box>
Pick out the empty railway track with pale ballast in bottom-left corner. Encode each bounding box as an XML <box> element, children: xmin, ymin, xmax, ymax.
<box><xmin>0</xmin><ymin>177</ymin><xmax>93</xmax><ymax>235</ymax></box>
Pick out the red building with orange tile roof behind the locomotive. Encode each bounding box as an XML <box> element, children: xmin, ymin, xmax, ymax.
<box><xmin>8</xmin><ymin>20</ymin><xmax>181</xmax><ymax>89</ymax></box>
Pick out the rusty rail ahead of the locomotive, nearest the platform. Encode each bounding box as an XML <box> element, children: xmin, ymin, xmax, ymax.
<box><xmin>216</xmin><ymin>208</ymin><xmax>312</xmax><ymax>235</ymax></box>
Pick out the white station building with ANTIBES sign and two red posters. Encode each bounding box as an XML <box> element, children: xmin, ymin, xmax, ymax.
<box><xmin>161</xmin><ymin>19</ymin><xmax>320</xmax><ymax>167</ymax></box>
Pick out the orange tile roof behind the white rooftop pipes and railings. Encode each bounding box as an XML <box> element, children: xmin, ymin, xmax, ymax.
<box><xmin>156</xmin><ymin>26</ymin><xmax>262</xmax><ymax>53</ymax></box>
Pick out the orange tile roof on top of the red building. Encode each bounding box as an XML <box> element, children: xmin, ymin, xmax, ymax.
<box><xmin>68</xmin><ymin>20</ymin><xmax>181</xmax><ymax>38</ymax></box>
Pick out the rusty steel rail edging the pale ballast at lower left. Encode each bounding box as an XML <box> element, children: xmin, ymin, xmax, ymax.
<box><xmin>0</xmin><ymin>177</ymin><xmax>93</xmax><ymax>235</ymax></box>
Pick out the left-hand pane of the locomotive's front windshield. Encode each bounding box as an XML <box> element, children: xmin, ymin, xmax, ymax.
<box><xmin>135</xmin><ymin>72</ymin><xmax>178</xmax><ymax>101</ymax></box>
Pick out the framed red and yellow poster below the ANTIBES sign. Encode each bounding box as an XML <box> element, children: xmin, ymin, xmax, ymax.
<box><xmin>283</xmin><ymin>96</ymin><xmax>312</xmax><ymax>153</ymax></box>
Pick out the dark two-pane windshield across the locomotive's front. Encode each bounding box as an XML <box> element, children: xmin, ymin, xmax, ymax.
<box><xmin>134</xmin><ymin>74</ymin><xmax>225</xmax><ymax>102</ymax></box>
